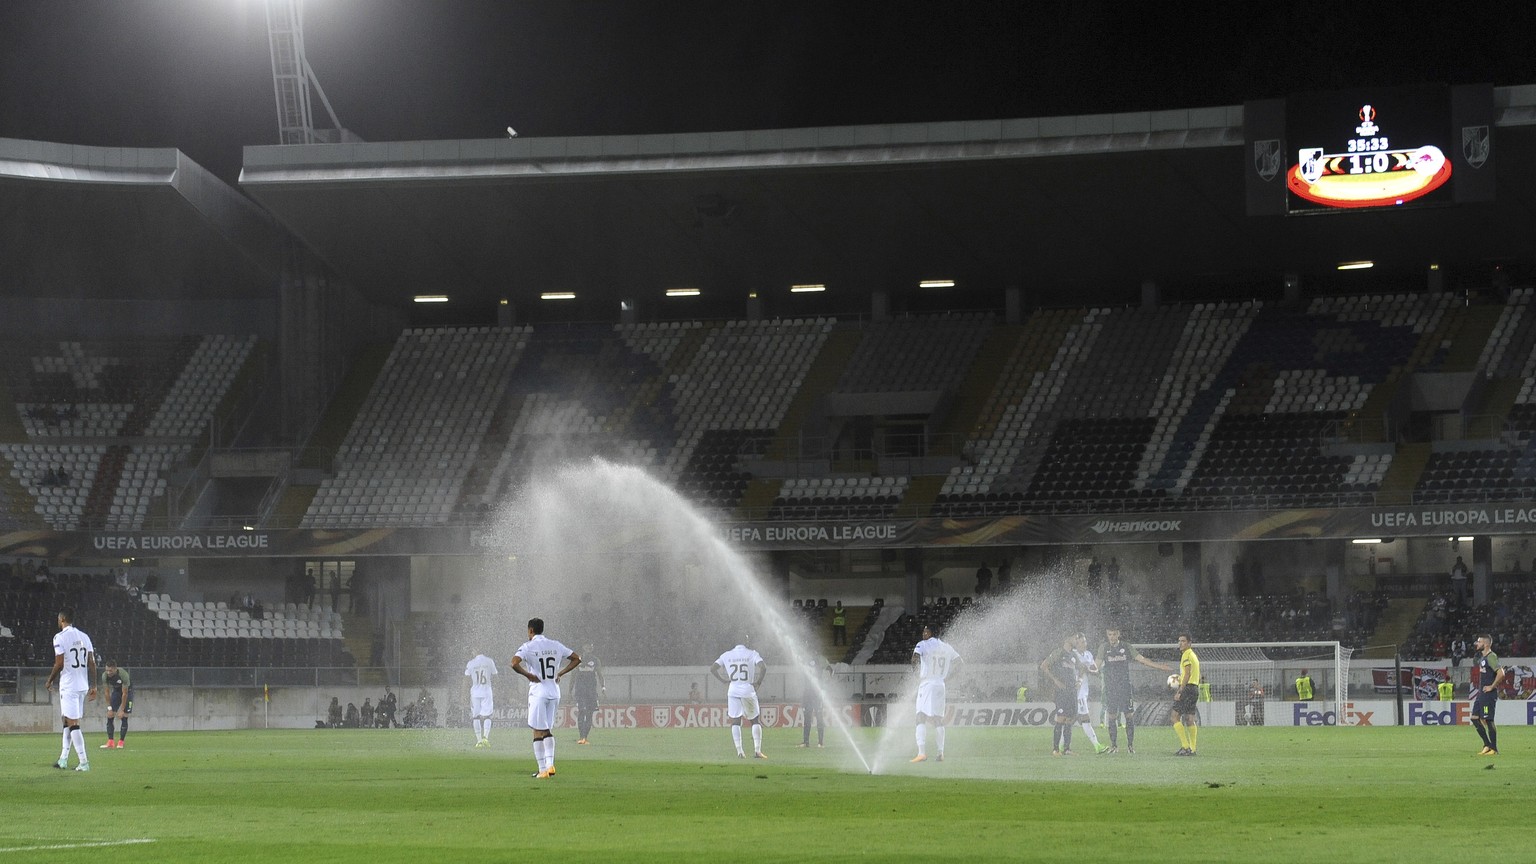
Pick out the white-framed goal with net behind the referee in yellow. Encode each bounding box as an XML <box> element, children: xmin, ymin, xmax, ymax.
<box><xmin>1132</xmin><ymin>643</ymin><xmax>1352</xmax><ymax>726</ymax></box>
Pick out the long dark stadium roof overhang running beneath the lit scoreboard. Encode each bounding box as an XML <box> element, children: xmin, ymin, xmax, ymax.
<box><xmin>241</xmin><ymin>88</ymin><xmax>1536</xmax><ymax>320</ymax></box>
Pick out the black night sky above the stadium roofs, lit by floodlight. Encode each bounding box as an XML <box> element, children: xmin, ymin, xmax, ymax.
<box><xmin>0</xmin><ymin>0</ymin><xmax>1536</xmax><ymax>181</ymax></box>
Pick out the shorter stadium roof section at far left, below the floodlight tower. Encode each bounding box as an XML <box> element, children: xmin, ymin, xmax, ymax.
<box><xmin>0</xmin><ymin>138</ymin><xmax>293</xmax><ymax>301</ymax></box>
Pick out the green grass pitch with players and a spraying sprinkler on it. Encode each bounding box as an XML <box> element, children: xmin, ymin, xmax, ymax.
<box><xmin>0</xmin><ymin>727</ymin><xmax>1536</xmax><ymax>864</ymax></box>
